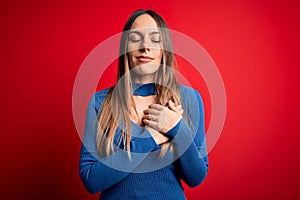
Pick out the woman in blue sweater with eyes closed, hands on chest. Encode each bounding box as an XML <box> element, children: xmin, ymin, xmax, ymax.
<box><xmin>80</xmin><ymin>10</ymin><xmax>208</xmax><ymax>200</ymax></box>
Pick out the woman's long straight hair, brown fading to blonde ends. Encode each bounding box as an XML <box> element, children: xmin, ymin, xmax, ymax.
<box><xmin>96</xmin><ymin>10</ymin><xmax>181</xmax><ymax>157</ymax></box>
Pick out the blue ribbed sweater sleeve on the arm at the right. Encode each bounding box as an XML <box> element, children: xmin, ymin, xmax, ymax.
<box><xmin>167</xmin><ymin>87</ymin><xmax>208</xmax><ymax>187</ymax></box>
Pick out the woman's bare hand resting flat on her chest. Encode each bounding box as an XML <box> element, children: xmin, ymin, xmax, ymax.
<box><xmin>143</xmin><ymin>100</ymin><xmax>183</xmax><ymax>133</ymax></box>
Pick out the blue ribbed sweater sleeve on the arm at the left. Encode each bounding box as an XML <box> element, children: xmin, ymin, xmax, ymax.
<box><xmin>79</xmin><ymin>93</ymin><xmax>157</xmax><ymax>194</ymax></box>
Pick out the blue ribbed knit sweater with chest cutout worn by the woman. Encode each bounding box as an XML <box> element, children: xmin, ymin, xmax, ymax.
<box><xmin>80</xmin><ymin>83</ymin><xmax>208</xmax><ymax>200</ymax></box>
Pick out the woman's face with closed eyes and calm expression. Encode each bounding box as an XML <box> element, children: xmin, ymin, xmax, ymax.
<box><xmin>128</xmin><ymin>14</ymin><xmax>162</xmax><ymax>81</ymax></box>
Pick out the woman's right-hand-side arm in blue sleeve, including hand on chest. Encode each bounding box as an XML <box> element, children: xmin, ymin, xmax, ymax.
<box><xmin>143</xmin><ymin>87</ymin><xmax>208</xmax><ymax>187</ymax></box>
